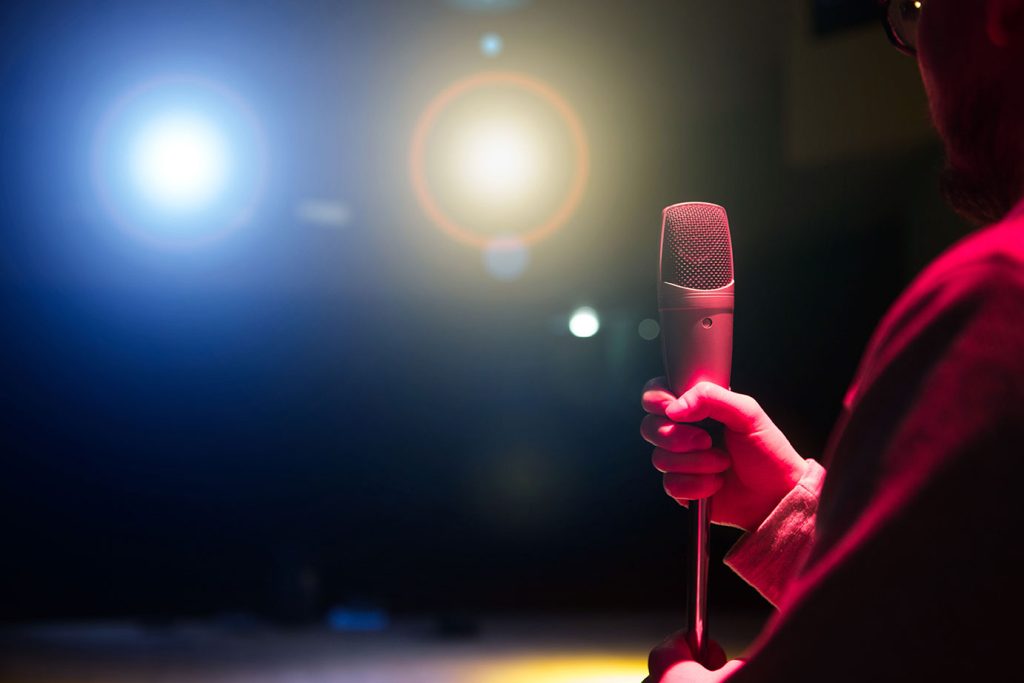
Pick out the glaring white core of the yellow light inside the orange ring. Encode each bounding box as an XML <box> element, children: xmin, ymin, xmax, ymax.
<box><xmin>456</xmin><ymin>121</ymin><xmax>541</xmax><ymax>203</ymax></box>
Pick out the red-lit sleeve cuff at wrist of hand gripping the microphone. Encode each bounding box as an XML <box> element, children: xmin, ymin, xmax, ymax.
<box><xmin>725</xmin><ymin>460</ymin><xmax>825</xmax><ymax>606</ymax></box>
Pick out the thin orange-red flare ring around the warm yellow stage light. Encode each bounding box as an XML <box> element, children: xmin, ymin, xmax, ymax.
<box><xmin>410</xmin><ymin>72</ymin><xmax>590</xmax><ymax>249</ymax></box>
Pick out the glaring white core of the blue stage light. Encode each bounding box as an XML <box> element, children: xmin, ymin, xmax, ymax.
<box><xmin>132</xmin><ymin>113</ymin><xmax>227</xmax><ymax>210</ymax></box>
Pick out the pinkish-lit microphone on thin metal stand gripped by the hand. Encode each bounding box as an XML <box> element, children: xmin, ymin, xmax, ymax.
<box><xmin>657</xmin><ymin>202</ymin><xmax>735</xmax><ymax>663</ymax></box>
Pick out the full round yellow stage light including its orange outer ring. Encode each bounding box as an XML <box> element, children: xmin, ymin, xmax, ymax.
<box><xmin>409</xmin><ymin>72</ymin><xmax>590</xmax><ymax>249</ymax></box>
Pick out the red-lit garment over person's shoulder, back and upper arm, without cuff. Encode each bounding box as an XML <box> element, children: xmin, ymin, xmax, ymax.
<box><xmin>730</xmin><ymin>200</ymin><xmax>1024</xmax><ymax>681</ymax></box>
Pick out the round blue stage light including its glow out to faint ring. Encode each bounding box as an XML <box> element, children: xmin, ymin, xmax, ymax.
<box><xmin>92</xmin><ymin>75</ymin><xmax>267</xmax><ymax>249</ymax></box>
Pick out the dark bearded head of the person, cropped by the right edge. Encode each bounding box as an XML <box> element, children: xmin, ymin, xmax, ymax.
<box><xmin>892</xmin><ymin>0</ymin><xmax>1024</xmax><ymax>223</ymax></box>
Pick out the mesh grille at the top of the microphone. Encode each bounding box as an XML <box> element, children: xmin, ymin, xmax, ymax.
<box><xmin>662</xmin><ymin>202</ymin><xmax>733</xmax><ymax>290</ymax></box>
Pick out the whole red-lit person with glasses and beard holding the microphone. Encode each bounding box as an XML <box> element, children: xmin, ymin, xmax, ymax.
<box><xmin>642</xmin><ymin>0</ymin><xmax>1024</xmax><ymax>683</ymax></box>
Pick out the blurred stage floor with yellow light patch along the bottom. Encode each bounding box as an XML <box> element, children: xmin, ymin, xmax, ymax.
<box><xmin>0</xmin><ymin>615</ymin><xmax>761</xmax><ymax>683</ymax></box>
